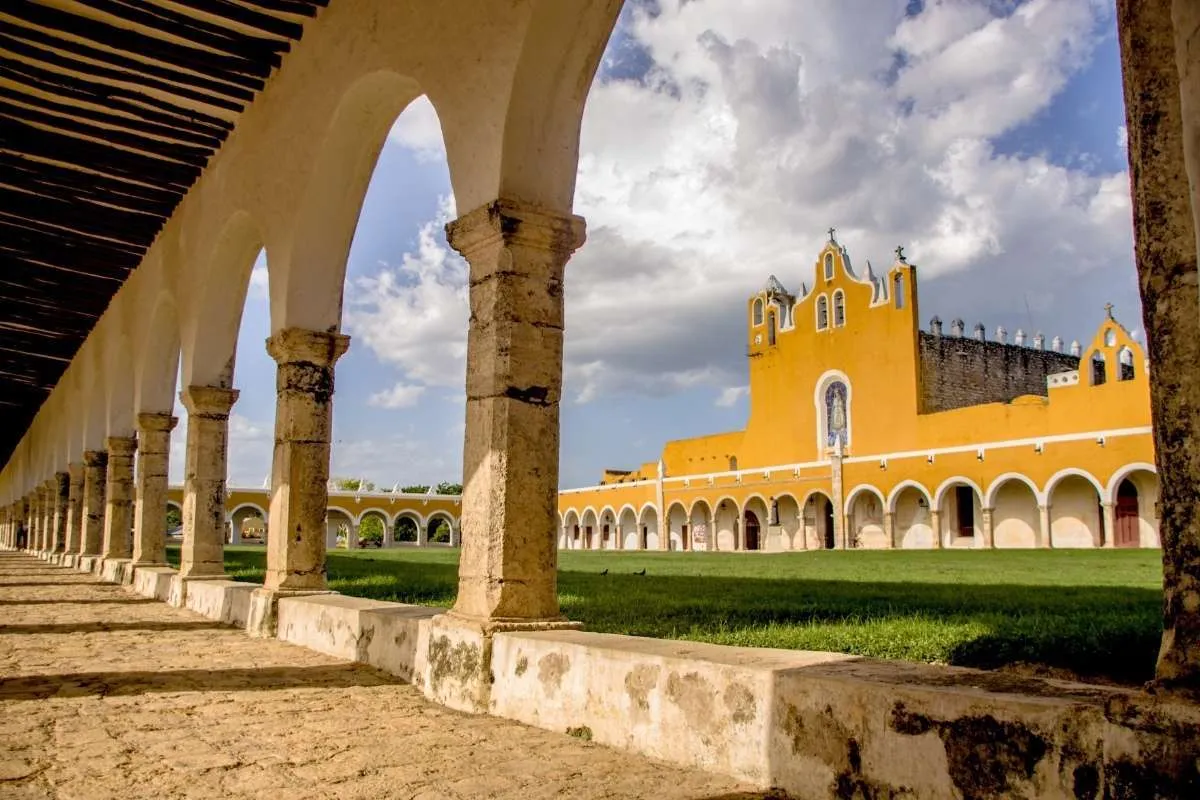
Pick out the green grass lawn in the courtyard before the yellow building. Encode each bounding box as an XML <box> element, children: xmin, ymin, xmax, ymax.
<box><xmin>172</xmin><ymin>547</ymin><xmax>1162</xmax><ymax>682</ymax></box>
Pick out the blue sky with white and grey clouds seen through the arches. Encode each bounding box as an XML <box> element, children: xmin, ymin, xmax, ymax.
<box><xmin>172</xmin><ymin>0</ymin><xmax>1141</xmax><ymax>488</ymax></box>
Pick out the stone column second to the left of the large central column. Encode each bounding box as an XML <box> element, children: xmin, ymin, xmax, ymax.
<box><xmin>176</xmin><ymin>386</ymin><xmax>237</xmax><ymax>578</ymax></box>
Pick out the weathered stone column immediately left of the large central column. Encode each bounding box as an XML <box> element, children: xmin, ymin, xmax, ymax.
<box><xmin>256</xmin><ymin>327</ymin><xmax>354</xmax><ymax>597</ymax></box>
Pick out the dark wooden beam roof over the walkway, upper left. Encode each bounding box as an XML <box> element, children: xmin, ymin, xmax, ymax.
<box><xmin>0</xmin><ymin>0</ymin><xmax>329</xmax><ymax>462</ymax></box>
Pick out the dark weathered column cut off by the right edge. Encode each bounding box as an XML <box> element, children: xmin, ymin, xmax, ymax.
<box><xmin>1117</xmin><ymin>0</ymin><xmax>1200</xmax><ymax>687</ymax></box>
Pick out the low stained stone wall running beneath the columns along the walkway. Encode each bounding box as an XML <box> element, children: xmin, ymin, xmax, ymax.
<box><xmin>56</xmin><ymin>556</ymin><xmax>1200</xmax><ymax>800</ymax></box>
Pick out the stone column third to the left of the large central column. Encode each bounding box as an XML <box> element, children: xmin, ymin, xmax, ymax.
<box><xmin>133</xmin><ymin>414</ymin><xmax>179</xmax><ymax>566</ymax></box>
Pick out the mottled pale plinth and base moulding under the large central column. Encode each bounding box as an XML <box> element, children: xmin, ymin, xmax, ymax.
<box><xmin>421</xmin><ymin>612</ymin><xmax>583</xmax><ymax>714</ymax></box>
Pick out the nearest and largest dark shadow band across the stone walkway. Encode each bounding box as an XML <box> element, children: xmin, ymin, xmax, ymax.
<box><xmin>0</xmin><ymin>663</ymin><xmax>403</xmax><ymax>700</ymax></box>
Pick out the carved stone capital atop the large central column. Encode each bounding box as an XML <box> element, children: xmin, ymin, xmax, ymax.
<box><xmin>445</xmin><ymin>198</ymin><xmax>587</xmax><ymax>260</ymax></box>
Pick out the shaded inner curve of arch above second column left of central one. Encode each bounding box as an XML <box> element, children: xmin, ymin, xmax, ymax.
<box><xmin>180</xmin><ymin>211</ymin><xmax>265</xmax><ymax>389</ymax></box>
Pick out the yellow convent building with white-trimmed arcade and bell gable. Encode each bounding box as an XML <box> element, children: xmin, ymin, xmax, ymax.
<box><xmin>559</xmin><ymin>231</ymin><xmax>1158</xmax><ymax>551</ymax></box>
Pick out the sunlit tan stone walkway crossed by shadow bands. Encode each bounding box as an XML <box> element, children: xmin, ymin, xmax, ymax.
<box><xmin>0</xmin><ymin>552</ymin><xmax>763</xmax><ymax>800</ymax></box>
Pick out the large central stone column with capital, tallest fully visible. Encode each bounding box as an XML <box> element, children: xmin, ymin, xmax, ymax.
<box><xmin>446</xmin><ymin>199</ymin><xmax>584</xmax><ymax>624</ymax></box>
